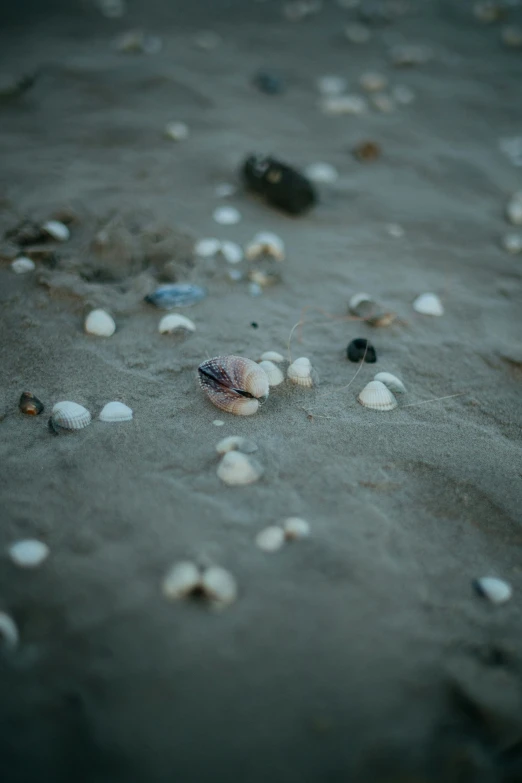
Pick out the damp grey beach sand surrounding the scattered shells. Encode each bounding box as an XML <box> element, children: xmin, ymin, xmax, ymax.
<box><xmin>0</xmin><ymin>0</ymin><xmax>522</xmax><ymax>783</ymax></box>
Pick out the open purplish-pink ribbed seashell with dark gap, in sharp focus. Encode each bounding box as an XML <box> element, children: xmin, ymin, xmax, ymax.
<box><xmin>198</xmin><ymin>356</ymin><xmax>269</xmax><ymax>416</ymax></box>
